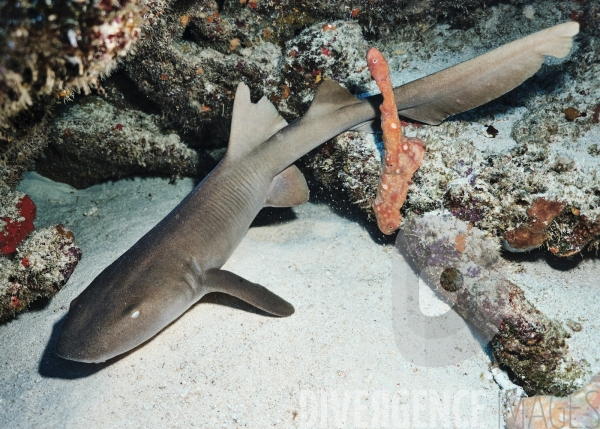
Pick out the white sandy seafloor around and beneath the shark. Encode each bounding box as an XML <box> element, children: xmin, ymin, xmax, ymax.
<box><xmin>0</xmin><ymin>173</ymin><xmax>600</xmax><ymax>428</ymax></box>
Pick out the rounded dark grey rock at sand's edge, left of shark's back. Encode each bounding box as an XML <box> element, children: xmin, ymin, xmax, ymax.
<box><xmin>36</xmin><ymin>96</ymin><xmax>199</xmax><ymax>189</ymax></box>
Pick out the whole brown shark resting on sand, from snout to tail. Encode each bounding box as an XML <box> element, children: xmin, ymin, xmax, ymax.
<box><xmin>56</xmin><ymin>22</ymin><xmax>579</xmax><ymax>362</ymax></box>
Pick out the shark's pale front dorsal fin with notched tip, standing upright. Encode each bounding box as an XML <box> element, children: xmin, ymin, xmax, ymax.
<box><xmin>227</xmin><ymin>82</ymin><xmax>287</xmax><ymax>158</ymax></box>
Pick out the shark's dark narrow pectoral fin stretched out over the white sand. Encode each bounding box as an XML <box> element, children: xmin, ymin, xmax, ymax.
<box><xmin>202</xmin><ymin>268</ymin><xmax>294</xmax><ymax>317</ymax></box>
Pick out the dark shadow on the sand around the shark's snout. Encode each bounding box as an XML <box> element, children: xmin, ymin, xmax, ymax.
<box><xmin>38</xmin><ymin>315</ymin><xmax>113</xmax><ymax>380</ymax></box>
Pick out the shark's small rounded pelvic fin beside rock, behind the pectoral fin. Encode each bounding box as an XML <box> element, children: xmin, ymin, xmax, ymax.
<box><xmin>265</xmin><ymin>165</ymin><xmax>308</xmax><ymax>207</ymax></box>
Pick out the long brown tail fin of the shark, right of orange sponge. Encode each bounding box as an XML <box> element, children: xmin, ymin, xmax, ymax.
<box><xmin>394</xmin><ymin>22</ymin><xmax>579</xmax><ymax>125</ymax></box>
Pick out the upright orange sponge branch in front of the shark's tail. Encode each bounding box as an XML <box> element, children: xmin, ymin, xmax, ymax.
<box><xmin>367</xmin><ymin>48</ymin><xmax>425</xmax><ymax>234</ymax></box>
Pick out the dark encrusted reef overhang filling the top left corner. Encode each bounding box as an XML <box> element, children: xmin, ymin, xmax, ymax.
<box><xmin>0</xmin><ymin>0</ymin><xmax>152</xmax><ymax>186</ymax></box>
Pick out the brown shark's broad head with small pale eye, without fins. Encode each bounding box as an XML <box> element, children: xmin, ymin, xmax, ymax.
<box><xmin>56</xmin><ymin>252</ymin><xmax>195</xmax><ymax>363</ymax></box>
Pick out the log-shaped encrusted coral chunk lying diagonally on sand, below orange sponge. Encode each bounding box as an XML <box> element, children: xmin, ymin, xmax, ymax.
<box><xmin>396</xmin><ymin>213</ymin><xmax>589</xmax><ymax>395</ymax></box>
